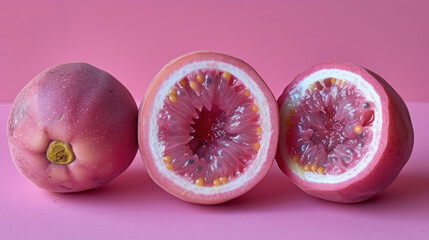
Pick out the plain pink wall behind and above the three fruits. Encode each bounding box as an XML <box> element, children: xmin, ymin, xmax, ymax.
<box><xmin>0</xmin><ymin>0</ymin><xmax>429</xmax><ymax>102</ymax></box>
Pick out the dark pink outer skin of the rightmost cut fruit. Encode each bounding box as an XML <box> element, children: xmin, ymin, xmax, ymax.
<box><xmin>276</xmin><ymin>62</ymin><xmax>414</xmax><ymax>203</ymax></box>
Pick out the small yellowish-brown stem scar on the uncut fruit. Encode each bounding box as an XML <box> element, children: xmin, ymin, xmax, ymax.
<box><xmin>46</xmin><ymin>140</ymin><xmax>75</xmax><ymax>165</ymax></box>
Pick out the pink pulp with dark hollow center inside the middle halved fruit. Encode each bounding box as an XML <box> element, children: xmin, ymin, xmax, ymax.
<box><xmin>158</xmin><ymin>69</ymin><xmax>262</xmax><ymax>187</ymax></box>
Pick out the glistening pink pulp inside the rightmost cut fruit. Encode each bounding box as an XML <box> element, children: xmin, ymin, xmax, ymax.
<box><xmin>286</xmin><ymin>78</ymin><xmax>374</xmax><ymax>175</ymax></box>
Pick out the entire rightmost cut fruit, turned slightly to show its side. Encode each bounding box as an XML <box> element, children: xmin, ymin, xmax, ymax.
<box><xmin>276</xmin><ymin>62</ymin><xmax>414</xmax><ymax>203</ymax></box>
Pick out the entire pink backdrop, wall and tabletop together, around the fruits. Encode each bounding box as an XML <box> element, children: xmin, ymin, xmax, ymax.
<box><xmin>0</xmin><ymin>0</ymin><xmax>429</xmax><ymax>239</ymax></box>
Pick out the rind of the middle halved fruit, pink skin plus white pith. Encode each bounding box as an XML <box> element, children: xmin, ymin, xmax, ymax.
<box><xmin>138</xmin><ymin>51</ymin><xmax>278</xmax><ymax>204</ymax></box>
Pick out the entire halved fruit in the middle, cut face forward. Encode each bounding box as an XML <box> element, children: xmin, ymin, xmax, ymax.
<box><xmin>138</xmin><ymin>51</ymin><xmax>278</xmax><ymax>204</ymax></box>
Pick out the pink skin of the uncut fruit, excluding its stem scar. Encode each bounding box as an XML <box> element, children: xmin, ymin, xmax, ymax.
<box><xmin>7</xmin><ymin>63</ymin><xmax>138</xmax><ymax>192</ymax></box>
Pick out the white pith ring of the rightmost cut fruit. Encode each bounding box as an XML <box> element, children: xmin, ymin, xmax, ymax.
<box><xmin>279</xmin><ymin>69</ymin><xmax>383</xmax><ymax>183</ymax></box>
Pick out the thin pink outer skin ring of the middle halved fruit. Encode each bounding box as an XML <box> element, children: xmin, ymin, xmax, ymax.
<box><xmin>138</xmin><ymin>51</ymin><xmax>279</xmax><ymax>204</ymax></box>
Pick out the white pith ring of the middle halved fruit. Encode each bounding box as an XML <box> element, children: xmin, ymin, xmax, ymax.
<box><xmin>148</xmin><ymin>61</ymin><xmax>272</xmax><ymax>194</ymax></box>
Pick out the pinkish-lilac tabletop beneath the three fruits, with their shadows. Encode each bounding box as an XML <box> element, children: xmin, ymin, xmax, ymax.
<box><xmin>0</xmin><ymin>103</ymin><xmax>429</xmax><ymax>240</ymax></box>
